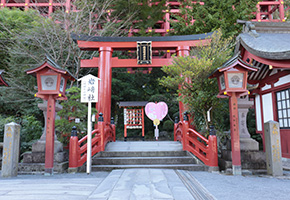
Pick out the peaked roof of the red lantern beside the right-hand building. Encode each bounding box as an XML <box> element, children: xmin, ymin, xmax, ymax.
<box><xmin>209</xmin><ymin>53</ymin><xmax>258</xmax><ymax>78</ymax></box>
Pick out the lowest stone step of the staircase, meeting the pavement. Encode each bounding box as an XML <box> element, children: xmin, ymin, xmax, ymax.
<box><xmin>92</xmin><ymin>164</ymin><xmax>208</xmax><ymax>171</ymax></box>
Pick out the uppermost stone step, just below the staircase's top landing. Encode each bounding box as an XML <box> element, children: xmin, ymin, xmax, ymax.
<box><xmin>95</xmin><ymin>151</ymin><xmax>188</xmax><ymax>157</ymax></box>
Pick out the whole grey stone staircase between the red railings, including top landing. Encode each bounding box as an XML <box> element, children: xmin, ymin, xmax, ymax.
<box><xmin>92</xmin><ymin>141</ymin><xmax>208</xmax><ymax>171</ymax></box>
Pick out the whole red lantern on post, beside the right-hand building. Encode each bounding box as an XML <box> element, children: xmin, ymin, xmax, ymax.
<box><xmin>209</xmin><ymin>55</ymin><xmax>258</xmax><ymax>175</ymax></box>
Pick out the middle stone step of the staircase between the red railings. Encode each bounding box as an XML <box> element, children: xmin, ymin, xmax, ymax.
<box><xmin>93</xmin><ymin>156</ymin><xmax>196</xmax><ymax>165</ymax></box>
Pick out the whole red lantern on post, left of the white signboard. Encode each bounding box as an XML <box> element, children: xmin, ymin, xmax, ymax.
<box><xmin>26</xmin><ymin>57</ymin><xmax>75</xmax><ymax>175</ymax></box>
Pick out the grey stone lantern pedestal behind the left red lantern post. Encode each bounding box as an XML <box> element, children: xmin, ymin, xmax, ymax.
<box><xmin>32</xmin><ymin>101</ymin><xmax>63</xmax><ymax>153</ymax></box>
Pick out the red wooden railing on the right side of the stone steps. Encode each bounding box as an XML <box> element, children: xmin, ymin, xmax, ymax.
<box><xmin>174</xmin><ymin>115</ymin><xmax>218</xmax><ymax>167</ymax></box>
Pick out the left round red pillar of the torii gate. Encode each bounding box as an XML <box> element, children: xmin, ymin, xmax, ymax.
<box><xmin>96</xmin><ymin>47</ymin><xmax>113</xmax><ymax>122</ymax></box>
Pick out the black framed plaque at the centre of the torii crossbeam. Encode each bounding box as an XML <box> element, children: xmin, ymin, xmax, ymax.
<box><xmin>137</xmin><ymin>41</ymin><xmax>152</xmax><ymax>65</ymax></box>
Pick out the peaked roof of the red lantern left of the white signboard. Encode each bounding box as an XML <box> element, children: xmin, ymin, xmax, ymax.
<box><xmin>26</xmin><ymin>55</ymin><xmax>76</xmax><ymax>81</ymax></box>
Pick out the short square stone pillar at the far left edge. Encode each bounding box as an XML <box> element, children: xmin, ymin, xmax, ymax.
<box><xmin>1</xmin><ymin>122</ymin><xmax>20</xmax><ymax>177</ymax></box>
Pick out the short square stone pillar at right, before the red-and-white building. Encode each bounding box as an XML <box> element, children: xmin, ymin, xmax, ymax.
<box><xmin>264</xmin><ymin>121</ymin><xmax>283</xmax><ymax>176</ymax></box>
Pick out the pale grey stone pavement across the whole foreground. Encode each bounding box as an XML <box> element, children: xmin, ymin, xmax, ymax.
<box><xmin>0</xmin><ymin>169</ymin><xmax>290</xmax><ymax>200</ymax></box>
